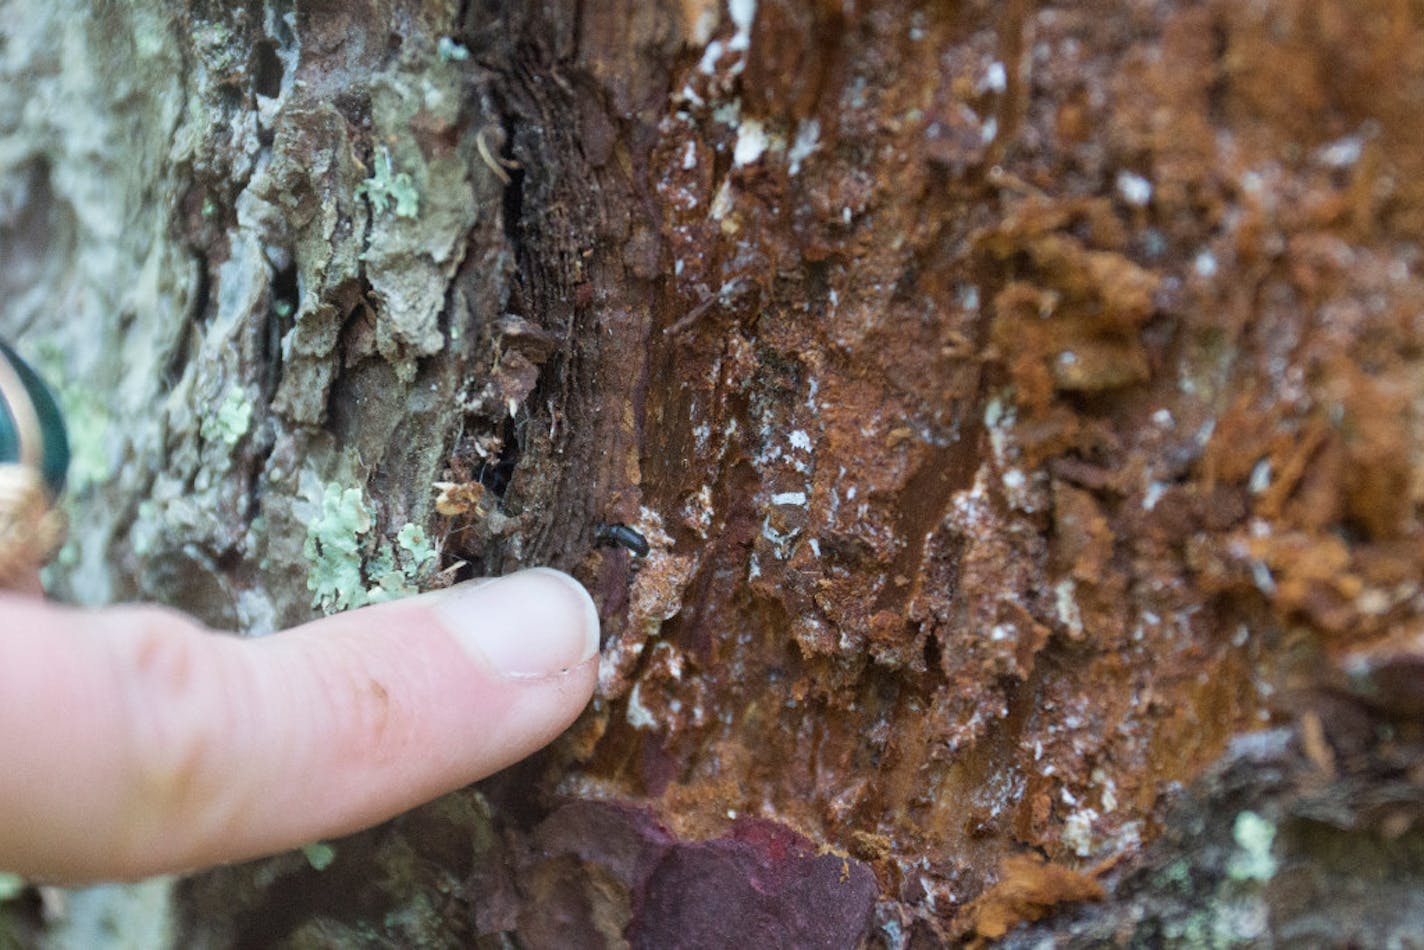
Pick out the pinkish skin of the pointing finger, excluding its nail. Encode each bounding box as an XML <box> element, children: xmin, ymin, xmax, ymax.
<box><xmin>0</xmin><ymin>583</ymin><xmax>597</xmax><ymax>882</ymax></box>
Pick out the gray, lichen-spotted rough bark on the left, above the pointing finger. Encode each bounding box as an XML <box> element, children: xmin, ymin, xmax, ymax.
<box><xmin>0</xmin><ymin>3</ymin><xmax>527</xmax><ymax>946</ymax></box>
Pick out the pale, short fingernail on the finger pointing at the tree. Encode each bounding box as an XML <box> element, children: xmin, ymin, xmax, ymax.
<box><xmin>431</xmin><ymin>567</ymin><xmax>598</xmax><ymax>677</ymax></box>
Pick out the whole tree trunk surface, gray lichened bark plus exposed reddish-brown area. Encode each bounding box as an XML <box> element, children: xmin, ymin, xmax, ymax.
<box><xmin>0</xmin><ymin>0</ymin><xmax>1424</xmax><ymax>947</ymax></box>
